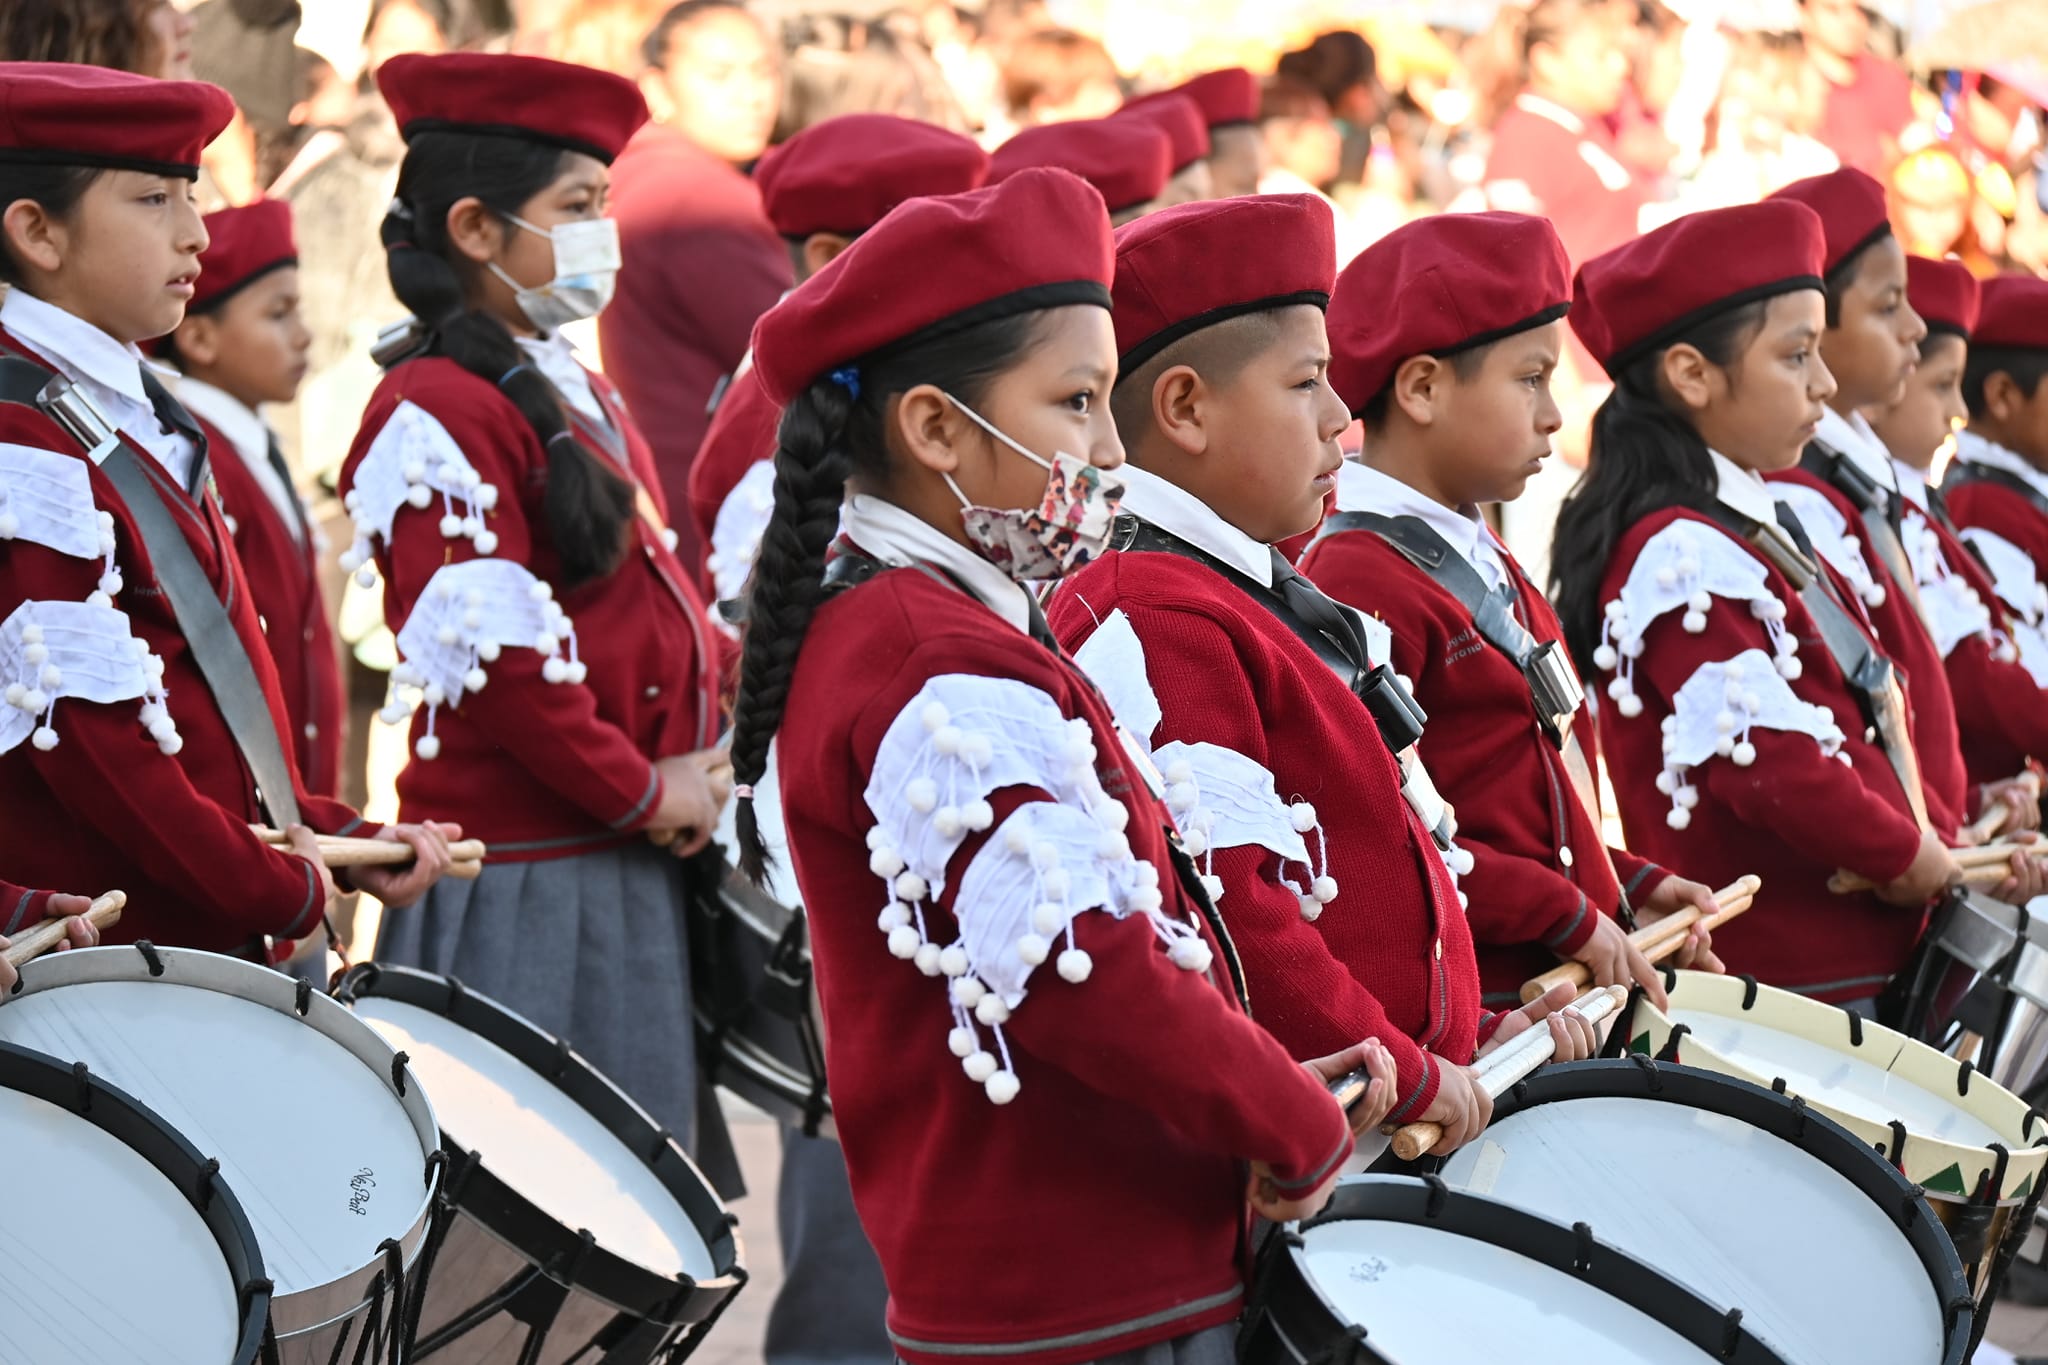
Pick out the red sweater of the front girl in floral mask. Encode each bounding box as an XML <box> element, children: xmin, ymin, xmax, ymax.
<box><xmin>776</xmin><ymin>569</ymin><xmax>1356</xmax><ymax>1365</ymax></box>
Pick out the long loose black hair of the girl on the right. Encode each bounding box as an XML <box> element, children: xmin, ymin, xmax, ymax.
<box><xmin>1550</xmin><ymin>299</ymin><xmax>1769</xmax><ymax>677</ymax></box>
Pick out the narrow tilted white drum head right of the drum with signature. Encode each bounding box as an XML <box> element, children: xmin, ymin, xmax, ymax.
<box><xmin>354</xmin><ymin>995</ymin><xmax>719</xmax><ymax>1281</ymax></box>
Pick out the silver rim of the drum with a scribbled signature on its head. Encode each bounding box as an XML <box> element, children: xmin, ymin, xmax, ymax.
<box><xmin>0</xmin><ymin>939</ymin><xmax>442</xmax><ymax>1338</ymax></box>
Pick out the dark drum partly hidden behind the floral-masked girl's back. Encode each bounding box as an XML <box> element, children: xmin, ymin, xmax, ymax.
<box><xmin>690</xmin><ymin>749</ymin><xmax>836</xmax><ymax>1138</ymax></box>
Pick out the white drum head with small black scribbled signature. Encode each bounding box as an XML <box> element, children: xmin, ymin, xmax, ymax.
<box><xmin>0</xmin><ymin>948</ymin><xmax>428</xmax><ymax>1301</ymax></box>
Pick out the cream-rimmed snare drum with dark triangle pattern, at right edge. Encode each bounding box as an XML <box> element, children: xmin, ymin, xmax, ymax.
<box><xmin>1618</xmin><ymin>972</ymin><xmax>2048</xmax><ymax>1312</ymax></box>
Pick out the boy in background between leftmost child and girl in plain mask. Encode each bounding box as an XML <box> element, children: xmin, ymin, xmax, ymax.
<box><xmin>160</xmin><ymin>199</ymin><xmax>348</xmax><ymax>796</ymax></box>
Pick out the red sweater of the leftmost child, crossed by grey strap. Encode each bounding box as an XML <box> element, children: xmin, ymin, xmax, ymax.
<box><xmin>0</xmin><ymin>334</ymin><xmax>360</xmax><ymax>952</ymax></box>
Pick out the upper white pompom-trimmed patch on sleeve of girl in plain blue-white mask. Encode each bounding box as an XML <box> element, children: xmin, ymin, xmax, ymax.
<box><xmin>342</xmin><ymin>401</ymin><xmax>498</xmax><ymax>587</ymax></box>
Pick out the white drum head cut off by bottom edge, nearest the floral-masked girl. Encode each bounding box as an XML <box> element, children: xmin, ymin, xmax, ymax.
<box><xmin>1300</xmin><ymin>1218</ymin><xmax>1712</xmax><ymax>1365</ymax></box>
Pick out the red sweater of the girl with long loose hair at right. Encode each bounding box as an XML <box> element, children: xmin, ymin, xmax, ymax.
<box><xmin>1599</xmin><ymin>508</ymin><xmax>1925</xmax><ymax>1001</ymax></box>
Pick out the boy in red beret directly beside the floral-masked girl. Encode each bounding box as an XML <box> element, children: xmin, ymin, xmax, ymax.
<box><xmin>1047</xmin><ymin>194</ymin><xmax>1589</xmax><ymax>1150</ymax></box>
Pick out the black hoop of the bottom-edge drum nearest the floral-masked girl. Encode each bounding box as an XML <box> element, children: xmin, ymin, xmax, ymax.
<box><xmin>1239</xmin><ymin>1175</ymin><xmax>1786</xmax><ymax>1365</ymax></box>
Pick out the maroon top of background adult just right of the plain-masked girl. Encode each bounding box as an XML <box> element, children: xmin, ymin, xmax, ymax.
<box><xmin>598</xmin><ymin>123</ymin><xmax>791</xmax><ymax>565</ymax></box>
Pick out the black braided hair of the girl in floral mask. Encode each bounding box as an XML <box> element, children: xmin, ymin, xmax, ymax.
<box><xmin>731</xmin><ymin>311</ymin><xmax>1044</xmax><ymax>882</ymax></box>
